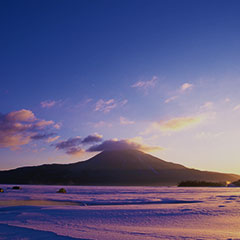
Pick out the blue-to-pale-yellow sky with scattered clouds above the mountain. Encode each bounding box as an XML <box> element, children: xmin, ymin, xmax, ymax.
<box><xmin>0</xmin><ymin>0</ymin><xmax>240</xmax><ymax>174</ymax></box>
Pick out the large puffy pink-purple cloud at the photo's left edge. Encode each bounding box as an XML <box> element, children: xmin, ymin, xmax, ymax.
<box><xmin>0</xmin><ymin>109</ymin><xmax>54</xmax><ymax>150</ymax></box>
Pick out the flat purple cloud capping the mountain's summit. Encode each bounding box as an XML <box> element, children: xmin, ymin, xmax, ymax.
<box><xmin>87</xmin><ymin>139</ymin><xmax>163</xmax><ymax>152</ymax></box>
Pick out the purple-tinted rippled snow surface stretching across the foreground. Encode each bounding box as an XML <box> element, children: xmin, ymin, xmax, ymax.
<box><xmin>0</xmin><ymin>185</ymin><xmax>240</xmax><ymax>240</ymax></box>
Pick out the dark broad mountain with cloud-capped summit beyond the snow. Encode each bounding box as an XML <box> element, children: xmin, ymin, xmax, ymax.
<box><xmin>0</xmin><ymin>150</ymin><xmax>240</xmax><ymax>185</ymax></box>
